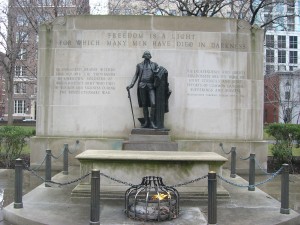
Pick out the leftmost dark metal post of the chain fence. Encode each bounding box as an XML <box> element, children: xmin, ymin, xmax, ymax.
<box><xmin>14</xmin><ymin>159</ymin><xmax>23</xmax><ymax>209</ymax></box>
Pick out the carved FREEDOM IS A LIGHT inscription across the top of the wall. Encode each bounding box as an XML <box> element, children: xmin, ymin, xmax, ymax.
<box><xmin>55</xmin><ymin>30</ymin><xmax>249</xmax><ymax>51</ymax></box>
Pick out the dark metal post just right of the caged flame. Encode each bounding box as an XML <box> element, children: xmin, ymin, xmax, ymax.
<box><xmin>208</xmin><ymin>171</ymin><xmax>217</xmax><ymax>224</ymax></box>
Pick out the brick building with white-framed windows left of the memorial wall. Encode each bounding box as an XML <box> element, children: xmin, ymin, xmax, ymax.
<box><xmin>4</xmin><ymin>0</ymin><xmax>90</xmax><ymax>119</ymax></box>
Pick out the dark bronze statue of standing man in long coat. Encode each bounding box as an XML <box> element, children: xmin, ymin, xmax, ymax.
<box><xmin>126</xmin><ymin>51</ymin><xmax>171</xmax><ymax>129</ymax></box>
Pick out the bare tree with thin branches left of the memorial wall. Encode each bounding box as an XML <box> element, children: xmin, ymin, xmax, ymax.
<box><xmin>0</xmin><ymin>0</ymin><xmax>89</xmax><ymax>124</ymax></box>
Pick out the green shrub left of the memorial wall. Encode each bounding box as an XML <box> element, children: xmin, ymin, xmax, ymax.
<box><xmin>0</xmin><ymin>126</ymin><xmax>33</xmax><ymax>168</ymax></box>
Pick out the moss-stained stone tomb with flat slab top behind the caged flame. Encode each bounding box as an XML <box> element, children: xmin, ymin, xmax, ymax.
<box><xmin>72</xmin><ymin>150</ymin><xmax>227</xmax><ymax>198</ymax></box>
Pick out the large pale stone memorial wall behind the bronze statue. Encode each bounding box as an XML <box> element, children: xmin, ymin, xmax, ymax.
<box><xmin>31</xmin><ymin>16</ymin><xmax>267</xmax><ymax>174</ymax></box>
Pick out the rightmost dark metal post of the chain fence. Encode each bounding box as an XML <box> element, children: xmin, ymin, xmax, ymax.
<box><xmin>280</xmin><ymin>164</ymin><xmax>290</xmax><ymax>214</ymax></box>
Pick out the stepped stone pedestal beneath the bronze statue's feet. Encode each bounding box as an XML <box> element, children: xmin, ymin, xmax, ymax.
<box><xmin>122</xmin><ymin>128</ymin><xmax>178</xmax><ymax>151</ymax></box>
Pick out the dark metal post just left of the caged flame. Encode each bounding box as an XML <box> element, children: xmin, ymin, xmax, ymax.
<box><xmin>90</xmin><ymin>169</ymin><xmax>100</xmax><ymax>225</ymax></box>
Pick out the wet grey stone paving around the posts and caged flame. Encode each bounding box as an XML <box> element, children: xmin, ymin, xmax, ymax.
<box><xmin>4</xmin><ymin>167</ymin><xmax>300</xmax><ymax>225</ymax></box>
